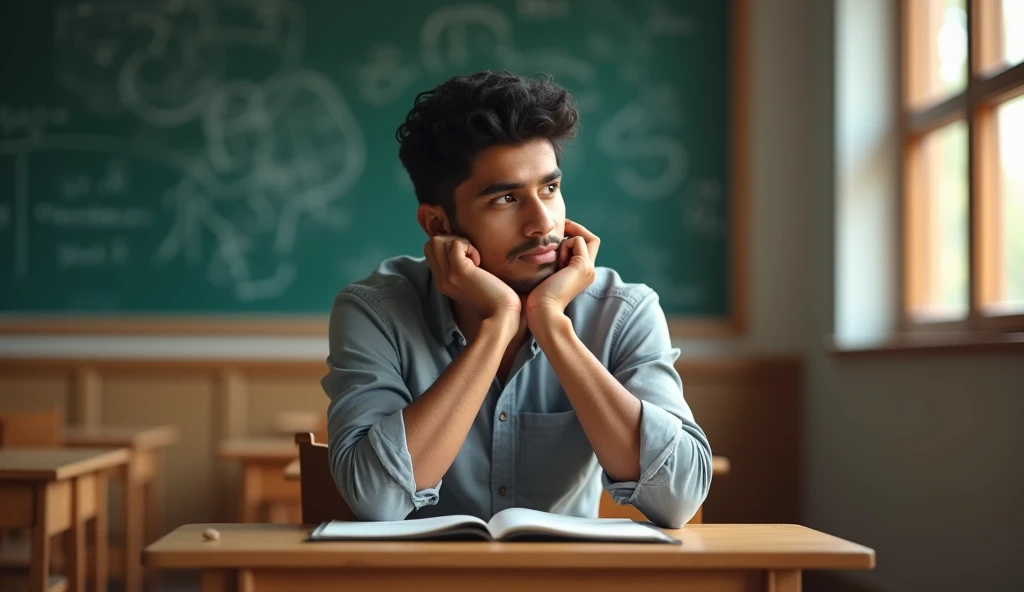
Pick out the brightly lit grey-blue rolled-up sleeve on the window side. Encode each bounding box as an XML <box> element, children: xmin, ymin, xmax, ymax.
<box><xmin>601</xmin><ymin>291</ymin><xmax>712</xmax><ymax>528</ymax></box>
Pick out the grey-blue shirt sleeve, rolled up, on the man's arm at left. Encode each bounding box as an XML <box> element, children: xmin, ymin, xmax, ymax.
<box><xmin>321</xmin><ymin>289</ymin><xmax>441</xmax><ymax>520</ymax></box>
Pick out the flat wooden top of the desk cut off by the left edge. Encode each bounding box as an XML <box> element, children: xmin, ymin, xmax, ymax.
<box><xmin>0</xmin><ymin>448</ymin><xmax>129</xmax><ymax>481</ymax></box>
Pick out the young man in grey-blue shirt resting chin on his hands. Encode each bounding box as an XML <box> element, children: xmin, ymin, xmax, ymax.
<box><xmin>322</xmin><ymin>72</ymin><xmax>712</xmax><ymax>527</ymax></box>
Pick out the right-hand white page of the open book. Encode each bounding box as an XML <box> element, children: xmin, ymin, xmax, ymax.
<box><xmin>488</xmin><ymin>508</ymin><xmax>676</xmax><ymax>542</ymax></box>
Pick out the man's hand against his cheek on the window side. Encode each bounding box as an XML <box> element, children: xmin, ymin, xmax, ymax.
<box><xmin>526</xmin><ymin>220</ymin><xmax>601</xmax><ymax>328</ymax></box>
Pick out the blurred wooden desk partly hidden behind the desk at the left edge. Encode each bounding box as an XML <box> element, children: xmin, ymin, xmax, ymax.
<box><xmin>63</xmin><ymin>425</ymin><xmax>178</xmax><ymax>592</ymax></box>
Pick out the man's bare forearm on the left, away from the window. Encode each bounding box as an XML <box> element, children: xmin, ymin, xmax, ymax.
<box><xmin>402</xmin><ymin>319</ymin><xmax>515</xmax><ymax>490</ymax></box>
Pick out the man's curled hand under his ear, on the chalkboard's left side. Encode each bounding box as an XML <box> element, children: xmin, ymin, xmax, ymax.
<box><xmin>423</xmin><ymin>235</ymin><xmax>522</xmax><ymax>323</ymax></box>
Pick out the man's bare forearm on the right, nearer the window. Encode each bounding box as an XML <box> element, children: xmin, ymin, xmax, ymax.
<box><xmin>531</xmin><ymin>314</ymin><xmax>642</xmax><ymax>481</ymax></box>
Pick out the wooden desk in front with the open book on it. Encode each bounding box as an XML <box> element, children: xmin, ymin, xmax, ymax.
<box><xmin>142</xmin><ymin>524</ymin><xmax>874</xmax><ymax>592</ymax></box>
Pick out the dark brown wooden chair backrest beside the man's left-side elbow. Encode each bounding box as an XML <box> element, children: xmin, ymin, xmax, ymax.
<box><xmin>295</xmin><ymin>432</ymin><xmax>356</xmax><ymax>524</ymax></box>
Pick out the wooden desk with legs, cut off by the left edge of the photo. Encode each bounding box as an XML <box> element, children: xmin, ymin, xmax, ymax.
<box><xmin>0</xmin><ymin>448</ymin><xmax>129</xmax><ymax>592</ymax></box>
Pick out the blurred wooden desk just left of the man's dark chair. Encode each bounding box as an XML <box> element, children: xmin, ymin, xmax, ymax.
<box><xmin>218</xmin><ymin>438</ymin><xmax>301</xmax><ymax>522</ymax></box>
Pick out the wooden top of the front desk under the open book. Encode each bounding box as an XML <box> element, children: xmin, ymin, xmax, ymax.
<box><xmin>142</xmin><ymin>523</ymin><xmax>874</xmax><ymax>569</ymax></box>
